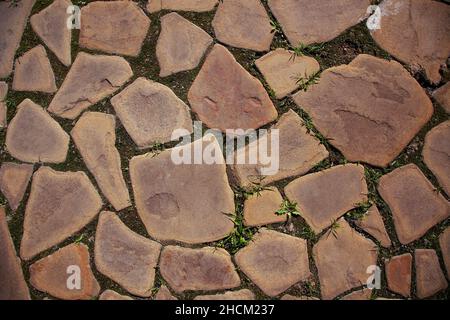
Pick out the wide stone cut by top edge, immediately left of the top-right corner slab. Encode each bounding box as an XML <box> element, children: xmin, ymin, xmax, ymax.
<box><xmin>268</xmin><ymin>0</ymin><xmax>370</xmax><ymax>47</ymax></box>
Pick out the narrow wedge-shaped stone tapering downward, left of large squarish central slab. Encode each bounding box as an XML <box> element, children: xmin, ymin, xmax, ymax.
<box><xmin>71</xmin><ymin>112</ymin><xmax>131</xmax><ymax>210</ymax></box>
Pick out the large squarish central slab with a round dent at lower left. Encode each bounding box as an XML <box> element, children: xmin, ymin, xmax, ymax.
<box><xmin>130</xmin><ymin>135</ymin><xmax>235</xmax><ymax>244</ymax></box>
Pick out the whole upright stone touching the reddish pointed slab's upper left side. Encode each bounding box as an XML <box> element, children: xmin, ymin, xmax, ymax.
<box><xmin>156</xmin><ymin>12</ymin><xmax>213</xmax><ymax>77</ymax></box>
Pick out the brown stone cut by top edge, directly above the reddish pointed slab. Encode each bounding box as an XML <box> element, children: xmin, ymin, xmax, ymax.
<box><xmin>212</xmin><ymin>0</ymin><xmax>275</xmax><ymax>51</ymax></box>
